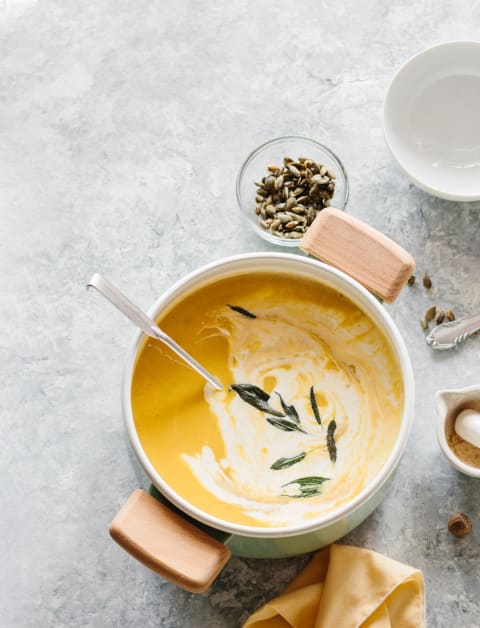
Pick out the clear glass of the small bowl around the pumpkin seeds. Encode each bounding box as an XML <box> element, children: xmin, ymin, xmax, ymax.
<box><xmin>237</xmin><ymin>135</ymin><xmax>349</xmax><ymax>247</ymax></box>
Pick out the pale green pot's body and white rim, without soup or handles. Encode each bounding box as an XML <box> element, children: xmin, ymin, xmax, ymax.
<box><xmin>122</xmin><ymin>253</ymin><xmax>414</xmax><ymax>558</ymax></box>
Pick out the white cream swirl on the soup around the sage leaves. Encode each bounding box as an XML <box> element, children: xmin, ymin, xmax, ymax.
<box><xmin>182</xmin><ymin>302</ymin><xmax>401</xmax><ymax>526</ymax></box>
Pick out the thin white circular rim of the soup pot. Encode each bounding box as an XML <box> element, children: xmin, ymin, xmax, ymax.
<box><xmin>122</xmin><ymin>252</ymin><xmax>414</xmax><ymax>538</ymax></box>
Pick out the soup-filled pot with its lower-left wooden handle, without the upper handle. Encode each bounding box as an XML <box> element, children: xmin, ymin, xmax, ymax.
<box><xmin>110</xmin><ymin>221</ymin><xmax>414</xmax><ymax>592</ymax></box>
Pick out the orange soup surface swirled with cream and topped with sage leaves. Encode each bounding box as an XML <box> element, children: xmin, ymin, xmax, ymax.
<box><xmin>131</xmin><ymin>272</ymin><xmax>403</xmax><ymax>527</ymax></box>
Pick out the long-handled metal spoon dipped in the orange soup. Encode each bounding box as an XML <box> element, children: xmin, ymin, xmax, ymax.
<box><xmin>87</xmin><ymin>273</ymin><xmax>223</xmax><ymax>390</ymax></box>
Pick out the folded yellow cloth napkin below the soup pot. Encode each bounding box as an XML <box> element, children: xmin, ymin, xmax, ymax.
<box><xmin>243</xmin><ymin>545</ymin><xmax>425</xmax><ymax>628</ymax></box>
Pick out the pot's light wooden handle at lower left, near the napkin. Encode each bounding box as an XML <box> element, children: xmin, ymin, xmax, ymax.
<box><xmin>110</xmin><ymin>489</ymin><xmax>230</xmax><ymax>593</ymax></box>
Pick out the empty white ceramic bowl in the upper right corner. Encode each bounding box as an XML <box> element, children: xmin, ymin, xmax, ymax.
<box><xmin>383</xmin><ymin>41</ymin><xmax>480</xmax><ymax>201</ymax></box>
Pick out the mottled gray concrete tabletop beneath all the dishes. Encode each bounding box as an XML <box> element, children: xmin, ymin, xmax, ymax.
<box><xmin>0</xmin><ymin>0</ymin><xmax>480</xmax><ymax>628</ymax></box>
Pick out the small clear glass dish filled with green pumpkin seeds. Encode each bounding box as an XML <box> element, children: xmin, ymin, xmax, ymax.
<box><xmin>237</xmin><ymin>135</ymin><xmax>349</xmax><ymax>247</ymax></box>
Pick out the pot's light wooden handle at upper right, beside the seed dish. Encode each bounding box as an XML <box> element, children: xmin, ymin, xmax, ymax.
<box><xmin>300</xmin><ymin>207</ymin><xmax>415</xmax><ymax>303</ymax></box>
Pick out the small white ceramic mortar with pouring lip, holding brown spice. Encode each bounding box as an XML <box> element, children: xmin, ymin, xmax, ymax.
<box><xmin>436</xmin><ymin>386</ymin><xmax>480</xmax><ymax>478</ymax></box>
